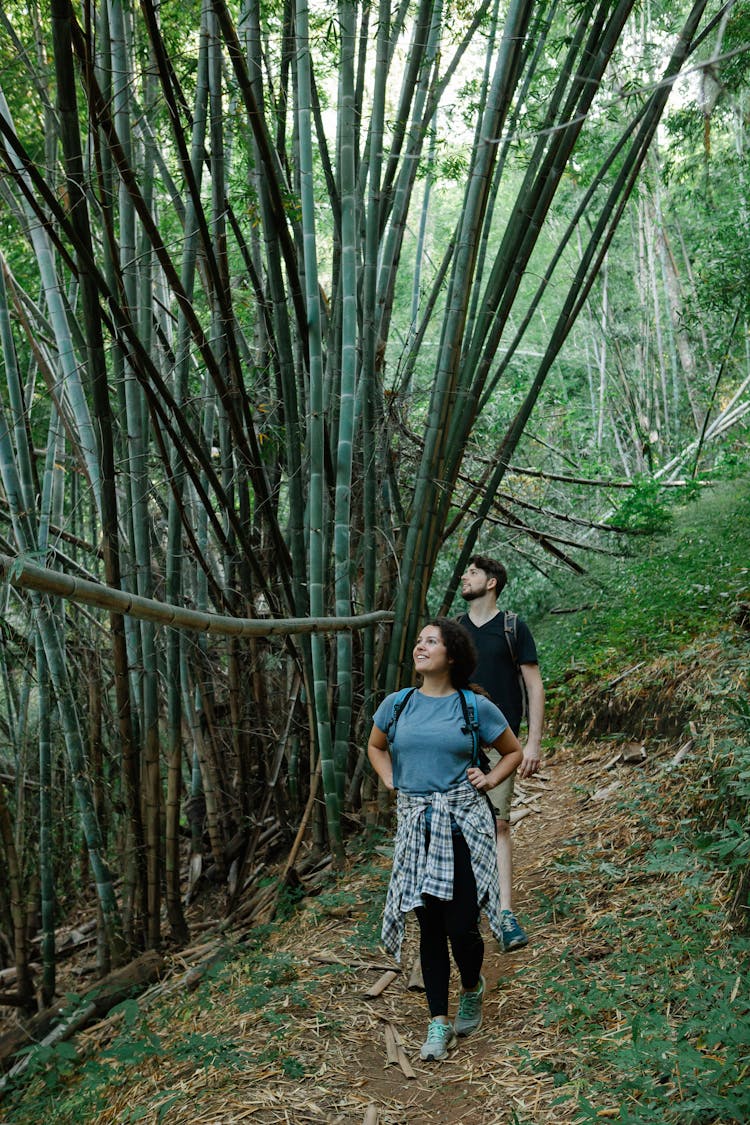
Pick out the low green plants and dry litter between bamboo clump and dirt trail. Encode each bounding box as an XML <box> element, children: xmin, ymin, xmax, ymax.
<box><xmin>0</xmin><ymin>846</ymin><xmax>386</xmax><ymax>1125</ymax></box>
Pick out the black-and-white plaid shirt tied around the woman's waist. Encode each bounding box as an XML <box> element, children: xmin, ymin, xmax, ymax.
<box><xmin>381</xmin><ymin>780</ymin><xmax>501</xmax><ymax>961</ymax></box>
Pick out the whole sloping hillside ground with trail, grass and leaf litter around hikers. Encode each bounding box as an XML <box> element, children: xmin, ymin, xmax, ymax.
<box><xmin>1</xmin><ymin>477</ymin><xmax>750</xmax><ymax>1125</ymax></box>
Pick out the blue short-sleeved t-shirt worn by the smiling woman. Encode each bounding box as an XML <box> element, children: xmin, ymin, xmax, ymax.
<box><xmin>372</xmin><ymin>690</ymin><xmax>507</xmax><ymax>795</ymax></box>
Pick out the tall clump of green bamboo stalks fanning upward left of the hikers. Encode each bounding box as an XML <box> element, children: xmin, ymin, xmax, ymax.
<box><xmin>0</xmin><ymin>0</ymin><xmax>746</xmax><ymax>1002</ymax></box>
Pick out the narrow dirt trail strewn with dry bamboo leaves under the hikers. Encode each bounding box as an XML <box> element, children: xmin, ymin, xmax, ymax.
<box><xmin>339</xmin><ymin>753</ymin><xmax>580</xmax><ymax>1125</ymax></box>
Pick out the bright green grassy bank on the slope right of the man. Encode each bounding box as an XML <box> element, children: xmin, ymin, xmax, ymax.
<box><xmin>528</xmin><ymin>480</ymin><xmax>750</xmax><ymax>693</ymax></box>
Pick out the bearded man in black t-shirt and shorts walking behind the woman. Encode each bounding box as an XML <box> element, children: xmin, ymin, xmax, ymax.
<box><xmin>459</xmin><ymin>555</ymin><xmax>544</xmax><ymax>953</ymax></box>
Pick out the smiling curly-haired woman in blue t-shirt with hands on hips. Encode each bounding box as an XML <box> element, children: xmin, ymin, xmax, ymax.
<box><xmin>368</xmin><ymin>618</ymin><xmax>522</xmax><ymax>1060</ymax></box>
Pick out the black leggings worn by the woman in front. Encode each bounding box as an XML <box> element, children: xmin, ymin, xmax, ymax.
<box><xmin>414</xmin><ymin>836</ymin><xmax>485</xmax><ymax>1016</ymax></box>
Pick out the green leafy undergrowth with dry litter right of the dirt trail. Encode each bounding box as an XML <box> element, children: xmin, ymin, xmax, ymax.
<box><xmin>524</xmin><ymin>699</ymin><xmax>750</xmax><ymax>1125</ymax></box>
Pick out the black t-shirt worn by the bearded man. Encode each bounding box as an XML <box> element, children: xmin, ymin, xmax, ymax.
<box><xmin>459</xmin><ymin>611</ymin><xmax>539</xmax><ymax>736</ymax></box>
